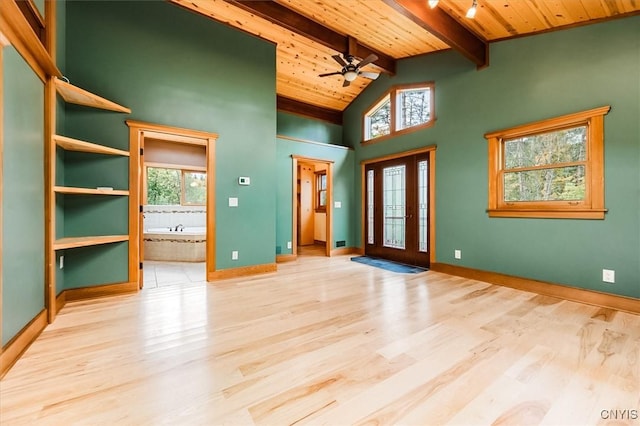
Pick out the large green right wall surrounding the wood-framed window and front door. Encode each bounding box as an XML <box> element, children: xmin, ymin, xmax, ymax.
<box><xmin>344</xmin><ymin>17</ymin><xmax>640</xmax><ymax>298</ymax></box>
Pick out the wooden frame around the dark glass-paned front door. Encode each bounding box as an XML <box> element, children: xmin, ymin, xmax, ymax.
<box><xmin>360</xmin><ymin>145</ymin><xmax>437</xmax><ymax>265</ymax></box>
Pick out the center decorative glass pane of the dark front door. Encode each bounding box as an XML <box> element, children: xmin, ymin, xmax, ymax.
<box><xmin>382</xmin><ymin>164</ymin><xmax>407</xmax><ymax>249</ymax></box>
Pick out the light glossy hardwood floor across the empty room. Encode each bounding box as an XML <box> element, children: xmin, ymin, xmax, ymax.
<box><xmin>0</xmin><ymin>256</ymin><xmax>640</xmax><ymax>425</ymax></box>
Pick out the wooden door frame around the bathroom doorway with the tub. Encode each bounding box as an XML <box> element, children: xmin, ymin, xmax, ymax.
<box><xmin>126</xmin><ymin>120</ymin><xmax>218</xmax><ymax>288</ymax></box>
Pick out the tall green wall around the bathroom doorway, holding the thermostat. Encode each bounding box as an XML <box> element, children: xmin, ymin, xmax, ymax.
<box><xmin>65</xmin><ymin>1</ymin><xmax>276</xmax><ymax>282</ymax></box>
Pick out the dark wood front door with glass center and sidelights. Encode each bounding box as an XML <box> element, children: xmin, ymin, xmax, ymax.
<box><xmin>364</xmin><ymin>152</ymin><xmax>429</xmax><ymax>267</ymax></box>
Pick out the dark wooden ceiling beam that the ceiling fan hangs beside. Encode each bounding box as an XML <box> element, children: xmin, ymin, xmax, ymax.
<box><xmin>225</xmin><ymin>0</ymin><xmax>396</xmax><ymax>74</ymax></box>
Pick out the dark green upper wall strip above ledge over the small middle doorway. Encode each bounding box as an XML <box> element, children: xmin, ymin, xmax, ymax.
<box><xmin>278</xmin><ymin>111</ymin><xmax>342</xmax><ymax>145</ymax></box>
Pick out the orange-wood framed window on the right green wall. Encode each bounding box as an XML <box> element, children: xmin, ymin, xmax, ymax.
<box><xmin>485</xmin><ymin>106</ymin><xmax>610</xmax><ymax>219</ymax></box>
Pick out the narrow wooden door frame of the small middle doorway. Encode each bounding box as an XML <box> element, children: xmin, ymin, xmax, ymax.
<box><xmin>291</xmin><ymin>155</ymin><xmax>334</xmax><ymax>257</ymax></box>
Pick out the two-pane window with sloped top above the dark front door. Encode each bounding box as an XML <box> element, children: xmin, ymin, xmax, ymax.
<box><xmin>363</xmin><ymin>83</ymin><xmax>434</xmax><ymax>142</ymax></box>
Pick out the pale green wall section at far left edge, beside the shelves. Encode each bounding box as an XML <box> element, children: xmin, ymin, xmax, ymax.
<box><xmin>1</xmin><ymin>46</ymin><xmax>44</xmax><ymax>346</ymax></box>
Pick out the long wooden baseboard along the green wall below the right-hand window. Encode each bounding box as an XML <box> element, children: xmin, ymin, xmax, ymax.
<box><xmin>429</xmin><ymin>263</ymin><xmax>640</xmax><ymax>315</ymax></box>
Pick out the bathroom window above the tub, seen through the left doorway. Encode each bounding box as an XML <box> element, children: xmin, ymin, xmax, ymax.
<box><xmin>146</xmin><ymin>166</ymin><xmax>207</xmax><ymax>206</ymax></box>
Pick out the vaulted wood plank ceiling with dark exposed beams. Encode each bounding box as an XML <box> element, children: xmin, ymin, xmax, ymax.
<box><xmin>171</xmin><ymin>0</ymin><xmax>640</xmax><ymax>122</ymax></box>
